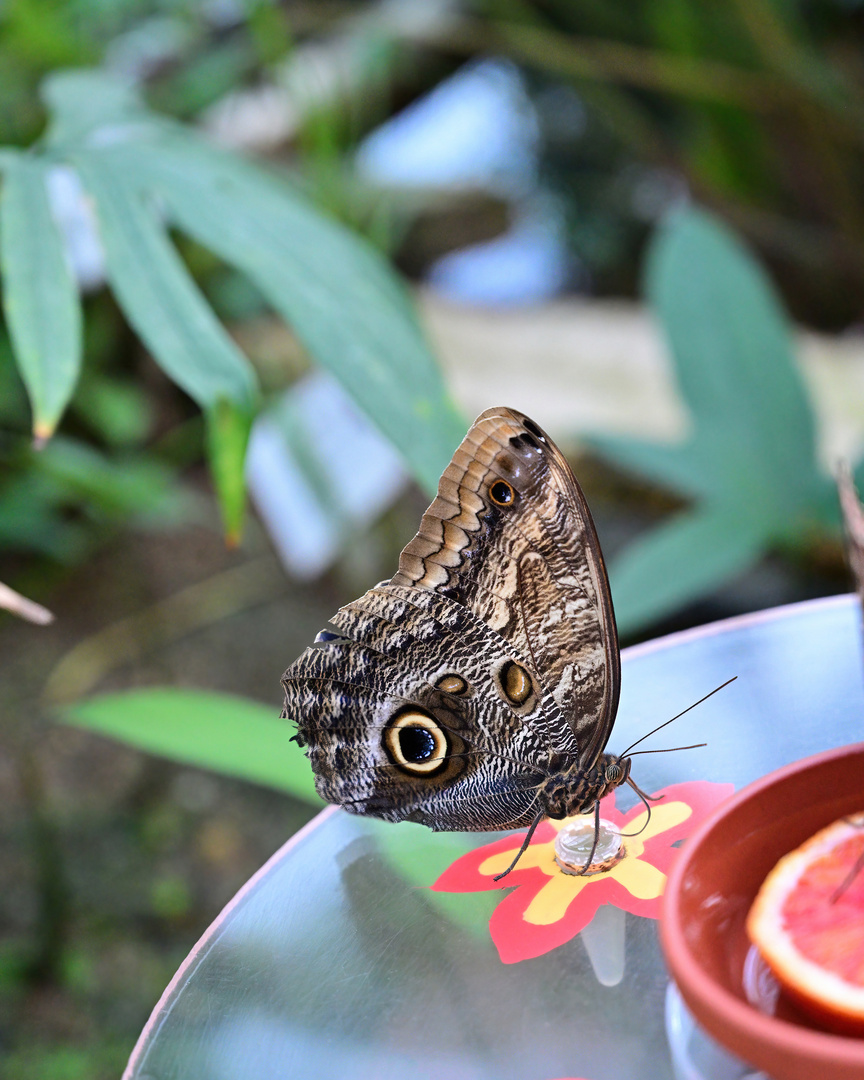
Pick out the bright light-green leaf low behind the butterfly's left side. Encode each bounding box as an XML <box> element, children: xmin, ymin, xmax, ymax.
<box><xmin>59</xmin><ymin>687</ymin><xmax>321</xmax><ymax>806</ymax></box>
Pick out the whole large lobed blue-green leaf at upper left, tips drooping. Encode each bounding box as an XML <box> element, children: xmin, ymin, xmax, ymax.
<box><xmin>0</xmin><ymin>72</ymin><xmax>462</xmax><ymax>541</ymax></box>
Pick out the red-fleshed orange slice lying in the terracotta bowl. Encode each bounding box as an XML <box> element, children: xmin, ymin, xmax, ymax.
<box><xmin>747</xmin><ymin>812</ymin><xmax>864</xmax><ymax>1035</ymax></box>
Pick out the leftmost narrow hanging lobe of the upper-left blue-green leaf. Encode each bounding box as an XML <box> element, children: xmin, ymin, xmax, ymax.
<box><xmin>0</xmin><ymin>156</ymin><xmax>81</xmax><ymax>440</ymax></box>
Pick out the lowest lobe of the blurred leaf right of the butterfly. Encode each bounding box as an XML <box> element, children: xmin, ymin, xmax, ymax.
<box><xmin>609</xmin><ymin>505</ymin><xmax>768</xmax><ymax>634</ymax></box>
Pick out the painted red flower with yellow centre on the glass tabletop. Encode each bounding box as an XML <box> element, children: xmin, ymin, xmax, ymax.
<box><xmin>432</xmin><ymin>781</ymin><xmax>733</xmax><ymax>963</ymax></box>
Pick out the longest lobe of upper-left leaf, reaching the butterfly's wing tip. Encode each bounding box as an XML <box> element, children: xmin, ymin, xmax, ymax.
<box><xmin>112</xmin><ymin>126</ymin><xmax>467</xmax><ymax>491</ymax></box>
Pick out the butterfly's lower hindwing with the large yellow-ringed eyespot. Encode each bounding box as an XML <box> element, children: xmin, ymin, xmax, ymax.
<box><xmin>282</xmin><ymin>582</ymin><xmax>555</xmax><ymax>831</ymax></box>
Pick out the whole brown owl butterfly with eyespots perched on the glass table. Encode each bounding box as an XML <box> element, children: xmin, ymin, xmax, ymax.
<box><xmin>282</xmin><ymin>408</ymin><xmax>645</xmax><ymax>876</ymax></box>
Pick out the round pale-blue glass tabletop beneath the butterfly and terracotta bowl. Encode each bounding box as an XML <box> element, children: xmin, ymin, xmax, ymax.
<box><xmin>125</xmin><ymin>596</ymin><xmax>864</xmax><ymax>1080</ymax></box>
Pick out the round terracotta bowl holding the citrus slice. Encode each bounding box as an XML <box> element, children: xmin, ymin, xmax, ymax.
<box><xmin>661</xmin><ymin>743</ymin><xmax>864</xmax><ymax>1080</ymax></box>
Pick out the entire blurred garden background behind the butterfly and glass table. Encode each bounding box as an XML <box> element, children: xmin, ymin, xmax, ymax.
<box><xmin>0</xmin><ymin>0</ymin><xmax>864</xmax><ymax>1080</ymax></box>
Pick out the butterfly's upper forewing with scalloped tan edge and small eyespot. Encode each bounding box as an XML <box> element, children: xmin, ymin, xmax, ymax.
<box><xmin>392</xmin><ymin>407</ymin><xmax>621</xmax><ymax>768</ymax></box>
